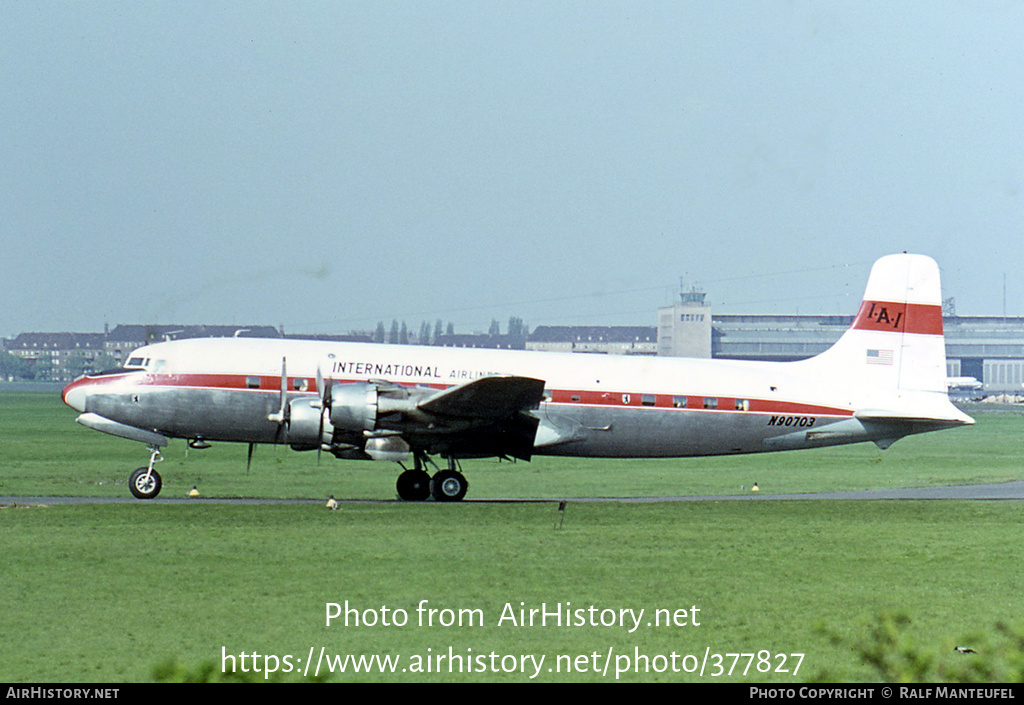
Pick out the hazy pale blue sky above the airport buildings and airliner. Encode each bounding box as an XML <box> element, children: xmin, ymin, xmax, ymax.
<box><xmin>0</xmin><ymin>0</ymin><xmax>1024</xmax><ymax>336</ymax></box>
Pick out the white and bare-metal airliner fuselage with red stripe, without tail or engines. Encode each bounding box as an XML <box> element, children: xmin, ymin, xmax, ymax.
<box><xmin>65</xmin><ymin>338</ymin><xmax>958</xmax><ymax>457</ymax></box>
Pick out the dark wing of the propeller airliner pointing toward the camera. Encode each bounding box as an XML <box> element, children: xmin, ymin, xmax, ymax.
<box><xmin>417</xmin><ymin>375</ymin><xmax>544</xmax><ymax>420</ymax></box>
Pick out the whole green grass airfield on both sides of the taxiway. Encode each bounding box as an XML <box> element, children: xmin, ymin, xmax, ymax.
<box><xmin>0</xmin><ymin>392</ymin><xmax>1024</xmax><ymax>682</ymax></box>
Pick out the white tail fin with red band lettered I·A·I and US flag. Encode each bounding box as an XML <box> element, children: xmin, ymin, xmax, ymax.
<box><xmin>796</xmin><ymin>254</ymin><xmax>973</xmax><ymax>425</ymax></box>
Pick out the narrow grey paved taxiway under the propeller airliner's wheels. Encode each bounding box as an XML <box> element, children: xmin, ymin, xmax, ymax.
<box><xmin>6</xmin><ymin>481</ymin><xmax>1024</xmax><ymax>506</ymax></box>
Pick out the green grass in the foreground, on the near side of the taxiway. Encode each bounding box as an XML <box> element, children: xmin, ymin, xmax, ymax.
<box><xmin>0</xmin><ymin>501</ymin><xmax>1024</xmax><ymax>682</ymax></box>
